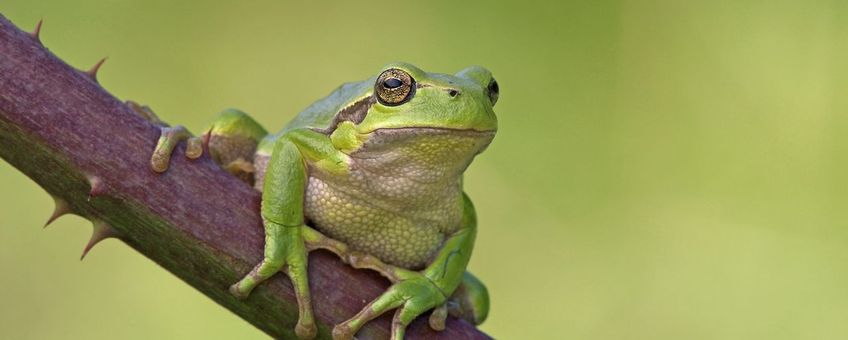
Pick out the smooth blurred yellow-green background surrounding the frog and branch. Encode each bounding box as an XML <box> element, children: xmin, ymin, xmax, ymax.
<box><xmin>0</xmin><ymin>0</ymin><xmax>848</xmax><ymax>339</ymax></box>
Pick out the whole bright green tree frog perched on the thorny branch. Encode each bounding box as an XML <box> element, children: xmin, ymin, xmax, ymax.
<box><xmin>146</xmin><ymin>63</ymin><xmax>498</xmax><ymax>339</ymax></box>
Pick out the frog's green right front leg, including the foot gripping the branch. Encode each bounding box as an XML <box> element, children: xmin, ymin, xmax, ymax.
<box><xmin>333</xmin><ymin>196</ymin><xmax>488</xmax><ymax>340</ymax></box>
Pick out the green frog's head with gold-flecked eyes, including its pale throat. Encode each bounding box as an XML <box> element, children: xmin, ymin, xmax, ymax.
<box><xmin>336</xmin><ymin>63</ymin><xmax>498</xmax><ymax>180</ymax></box>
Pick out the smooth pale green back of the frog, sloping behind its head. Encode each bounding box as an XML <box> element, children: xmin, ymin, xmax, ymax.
<box><xmin>257</xmin><ymin>78</ymin><xmax>374</xmax><ymax>155</ymax></box>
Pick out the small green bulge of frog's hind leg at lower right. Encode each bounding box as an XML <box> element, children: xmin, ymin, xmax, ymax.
<box><xmin>450</xmin><ymin>271</ymin><xmax>489</xmax><ymax>325</ymax></box>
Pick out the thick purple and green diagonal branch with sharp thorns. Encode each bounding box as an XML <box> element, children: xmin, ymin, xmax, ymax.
<box><xmin>0</xmin><ymin>15</ymin><xmax>488</xmax><ymax>339</ymax></box>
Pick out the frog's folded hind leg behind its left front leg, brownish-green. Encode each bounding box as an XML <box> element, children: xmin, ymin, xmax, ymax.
<box><xmin>207</xmin><ymin>109</ymin><xmax>268</xmax><ymax>181</ymax></box>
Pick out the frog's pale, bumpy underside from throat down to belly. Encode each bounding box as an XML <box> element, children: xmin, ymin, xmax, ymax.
<box><xmin>255</xmin><ymin>128</ymin><xmax>494</xmax><ymax>269</ymax></box>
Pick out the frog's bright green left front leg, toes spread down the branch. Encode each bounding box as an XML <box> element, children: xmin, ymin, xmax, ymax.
<box><xmin>230</xmin><ymin>129</ymin><xmax>347</xmax><ymax>338</ymax></box>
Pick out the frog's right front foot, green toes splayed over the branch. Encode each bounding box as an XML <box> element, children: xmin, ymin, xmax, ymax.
<box><xmin>333</xmin><ymin>273</ymin><xmax>447</xmax><ymax>340</ymax></box>
